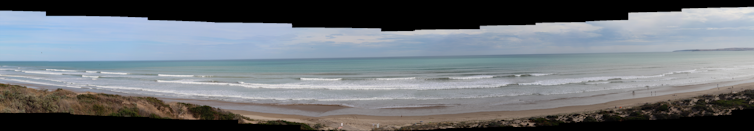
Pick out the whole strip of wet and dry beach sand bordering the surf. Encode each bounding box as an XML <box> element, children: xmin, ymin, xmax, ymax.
<box><xmin>4</xmin><ymin>79</ymin><xmax>754</xmax><ymax>130</ymax></box>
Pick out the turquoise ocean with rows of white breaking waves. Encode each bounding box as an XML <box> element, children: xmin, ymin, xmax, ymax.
<box><xmin>0</xmin><ymin>51</ymin><xmax>754</xmax><ymax>116</ymax></box>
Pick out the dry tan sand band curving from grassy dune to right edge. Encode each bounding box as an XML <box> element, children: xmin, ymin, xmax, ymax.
<box><xmin>223</xmin><ymin>80</ymin><xmax>754</xmax><ymax>130</ymax></box>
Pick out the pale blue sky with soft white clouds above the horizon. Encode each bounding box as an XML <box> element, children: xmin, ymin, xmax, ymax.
<box><xmin>0</xmin><ymin>8</ymin><xmax>754</xmax><ymax>61</ymax></box>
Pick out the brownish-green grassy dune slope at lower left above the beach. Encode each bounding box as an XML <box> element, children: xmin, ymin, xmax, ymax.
<box><xmin>0</xmin><ymin>83</ymin><xmax>324</xmax><ymax>130</ymax></box>
